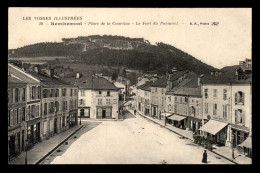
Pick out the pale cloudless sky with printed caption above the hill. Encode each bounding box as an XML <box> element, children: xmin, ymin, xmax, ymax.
<box><xmin>8</xmin><ymin>7</ymin><xmax>252</xmax><ymax>68</ymax></box>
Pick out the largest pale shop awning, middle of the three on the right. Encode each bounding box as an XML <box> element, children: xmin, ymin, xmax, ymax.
<box><xmin>199</xmin><ymin>120</ymin><xmax>228</xmax><ymax>135</ymax></box>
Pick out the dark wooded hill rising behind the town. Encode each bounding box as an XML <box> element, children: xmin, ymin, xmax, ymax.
<box><xmin>9</xmin><ymin>35</ymin><xmax>217</xmax><ymax>74</ymax></box>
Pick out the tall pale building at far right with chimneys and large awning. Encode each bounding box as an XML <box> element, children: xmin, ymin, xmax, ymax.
<box><xmin>200</xmin><ymin>64</ymin><xmax>252</xmax><ymax>147</ymax></box>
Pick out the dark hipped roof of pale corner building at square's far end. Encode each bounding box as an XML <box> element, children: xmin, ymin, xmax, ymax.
<box><xmin>74</xmin><ymin>76</ymin><xmax>119</xmax><ymax>90</ymax></box>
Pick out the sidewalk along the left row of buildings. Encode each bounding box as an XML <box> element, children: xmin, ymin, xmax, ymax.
<box><xmin>9</xmin><ymin>125</ymin><xmax>83</xmax><ymax>164</ymax></box>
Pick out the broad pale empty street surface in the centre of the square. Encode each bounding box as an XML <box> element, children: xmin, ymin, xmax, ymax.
<box><xmin>50</xmin><ymin>113</ymin><xmax>233</xmax><ymax>164</ymax></box>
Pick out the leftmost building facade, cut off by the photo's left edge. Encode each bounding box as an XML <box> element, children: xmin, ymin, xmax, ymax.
<box><xmin>8</xmin><ymin>76</ymin><xmax>27</xmax><ymax>161</ymax></box>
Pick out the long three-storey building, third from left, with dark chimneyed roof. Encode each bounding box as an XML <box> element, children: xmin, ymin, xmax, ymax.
<box><xmin>28</xmin><ymin>69</ymin><xmax>78</xmax><ymax>140</ymax></box>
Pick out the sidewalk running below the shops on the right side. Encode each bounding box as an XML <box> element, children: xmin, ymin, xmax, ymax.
<box><xmin>128</xmin><ymin>109</ymin><xmax>252</xmax><ymax>164</ymax></box>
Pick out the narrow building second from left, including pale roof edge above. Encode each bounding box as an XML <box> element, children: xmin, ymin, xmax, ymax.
<box><xmin>8</xmin><ymin>63</ymin><xmax>42</xmax><ymax>146</ymax></box>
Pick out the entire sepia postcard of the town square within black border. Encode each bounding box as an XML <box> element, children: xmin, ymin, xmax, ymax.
<box><xmin>6</xmin><ymin>7</ymin><xmax>252</xmax><ymax>166</ymax></box>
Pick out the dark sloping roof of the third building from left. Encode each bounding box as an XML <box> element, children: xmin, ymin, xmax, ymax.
<box><xmin>28</xmin><ymin>72</ymin><xmax>71</xmax><ymax>86</ymax></box>
